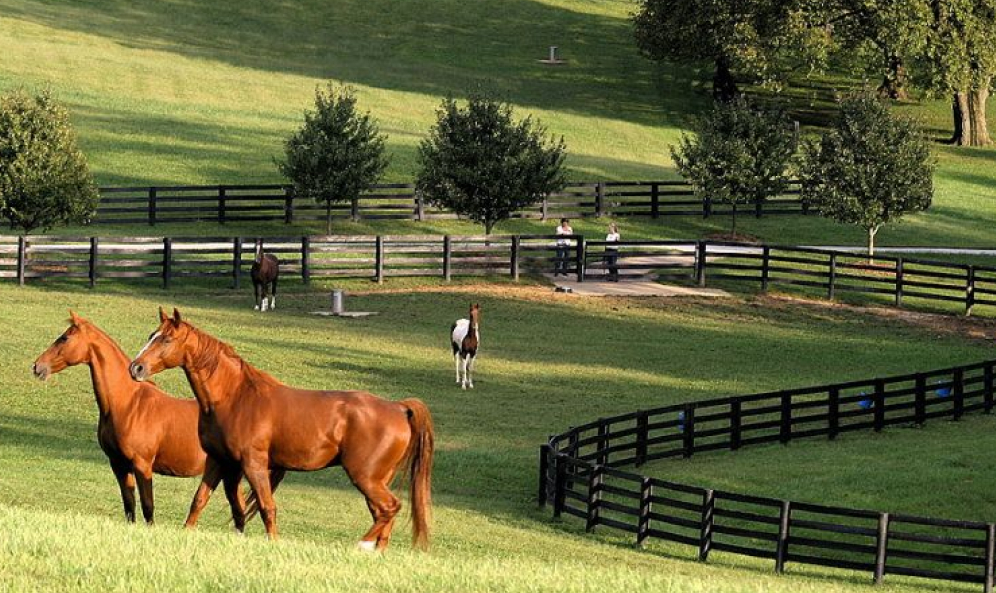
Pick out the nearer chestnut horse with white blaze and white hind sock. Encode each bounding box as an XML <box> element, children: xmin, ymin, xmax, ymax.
<box><xmin>131</xmin><ymin>309</ymin><xmax>434</xmax><ymax>550</ymax></box>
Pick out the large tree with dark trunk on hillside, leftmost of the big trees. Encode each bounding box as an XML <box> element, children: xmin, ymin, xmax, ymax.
<box><xmin>633</xmin><ymin>0</ymin><xmax>827</xmax><ymax>102</ymax></box>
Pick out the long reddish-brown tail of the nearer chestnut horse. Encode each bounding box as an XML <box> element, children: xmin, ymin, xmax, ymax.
<box><xmin>399</xmin><ymin>399</ymin><xmax>435</xmax><ymax>550</ymax></box>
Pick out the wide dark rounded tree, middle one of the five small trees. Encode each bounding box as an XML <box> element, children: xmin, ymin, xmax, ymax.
<box><xmin>415</xmin><ymin>95</ymin><xmax>567</xmax><ymax>234</ymax></box>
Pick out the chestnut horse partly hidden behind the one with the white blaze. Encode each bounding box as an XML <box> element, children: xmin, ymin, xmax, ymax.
<box><xmin>33</xmin><ymin>311</ymin><xmax>244</xmax><ymax>530</ymax></box>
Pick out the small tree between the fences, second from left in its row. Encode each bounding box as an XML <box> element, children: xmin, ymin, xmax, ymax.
<box><xmin>277</xmin><ymin>83</ymin><xmax>388</xmax><ymax>233</ymax></box>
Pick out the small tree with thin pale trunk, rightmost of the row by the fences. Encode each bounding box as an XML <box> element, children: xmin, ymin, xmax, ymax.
<box><xmin>800</xmin><ymin>91</ymin><xmax>934</xmax><ymax>258</ymax></box>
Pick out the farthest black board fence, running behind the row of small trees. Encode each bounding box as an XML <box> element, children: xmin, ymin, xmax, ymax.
<box><xmin>93</xmin><ymin>181</ymin><xmax>803</xmax><ymax>225</ymax></box>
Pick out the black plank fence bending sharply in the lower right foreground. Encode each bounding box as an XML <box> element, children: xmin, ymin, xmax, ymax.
<box><xmin>539</xmin><ymin>361</ymin><xmax>996</xmax><ymax>593</ymax></box>
